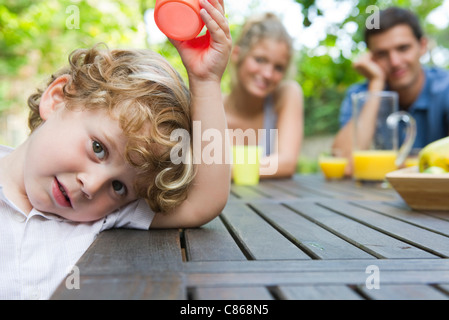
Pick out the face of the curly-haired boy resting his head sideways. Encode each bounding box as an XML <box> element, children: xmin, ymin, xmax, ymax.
<box><xmin>24</xmin><ymin>102</ymin><xmax>137</xmax><ymax>222</ymax></box>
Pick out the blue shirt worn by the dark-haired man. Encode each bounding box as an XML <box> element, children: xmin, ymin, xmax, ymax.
<box><xmin>340</xmin><ymin>67</ymin><xmax>449</xmax><ymax>148</ymax></box>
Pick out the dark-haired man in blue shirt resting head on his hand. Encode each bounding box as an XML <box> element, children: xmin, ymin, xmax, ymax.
<box><xmin>333</xmin><ymin>7</ymin><xmax>449</xmax><ymax>174</ymax></box>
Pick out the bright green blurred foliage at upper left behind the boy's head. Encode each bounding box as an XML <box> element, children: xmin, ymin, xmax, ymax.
<box><xmin>0</xmin><ymin>0</ymin><xmax>154</xmax><ymax>144</ymax></box>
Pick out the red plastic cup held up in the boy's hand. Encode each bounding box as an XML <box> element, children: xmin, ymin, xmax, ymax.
<box><xmin>154</xmin><ymin>0</ymin><xmax>204</xmax><ymax>41</ymax></box>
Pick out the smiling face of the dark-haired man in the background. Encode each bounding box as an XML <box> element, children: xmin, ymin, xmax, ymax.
<box><xmin>368</xmin><ymin>24</ymin><xmax>427</xmax><ymax>91</ymax></box>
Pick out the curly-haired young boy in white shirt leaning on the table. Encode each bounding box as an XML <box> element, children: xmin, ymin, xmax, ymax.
<box><xmin>0</xmin><ymin>0</ymin><xmax>231</xmax><ymax>299</ymax></box>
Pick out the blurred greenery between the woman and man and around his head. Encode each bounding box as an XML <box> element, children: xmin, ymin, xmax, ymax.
<box><xmin>296</xmin><ymin>0</ymin><xmax>449</xmax><ymax>135</ymax></box>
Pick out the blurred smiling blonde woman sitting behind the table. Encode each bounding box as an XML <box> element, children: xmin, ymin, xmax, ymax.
<box><xmin>224</xmin><ymin>13</ymin><xmax>304</xmax><ymax>178</ymax></box>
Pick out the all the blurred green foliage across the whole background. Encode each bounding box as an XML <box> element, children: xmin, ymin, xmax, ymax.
<box><xmin>0</xmin><ymin>0</ymin><xmax>449</xmax><ymax>155</ymax></box>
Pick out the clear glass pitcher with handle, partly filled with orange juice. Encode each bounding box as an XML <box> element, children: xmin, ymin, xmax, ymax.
<box><xmin>351</xmin><ymin>91</ymin><xmax>416</xmax><ymax>181</ymax></box>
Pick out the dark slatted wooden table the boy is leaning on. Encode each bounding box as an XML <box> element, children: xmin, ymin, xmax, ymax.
<box><xmin>53</xmin><ymin>175</ymin><xmax>449</xmax><ymax>300</ymax></box>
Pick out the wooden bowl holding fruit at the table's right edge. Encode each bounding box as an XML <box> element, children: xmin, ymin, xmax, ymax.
<box><xmin>386</xmin><ymin>166</ymin><xmax>449</xmax><ymax>210</ymax></box>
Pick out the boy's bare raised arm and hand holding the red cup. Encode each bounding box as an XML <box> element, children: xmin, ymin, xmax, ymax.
<box><xmin>151</xmin><ymin>0</ymin><xmax>232</xmax><ymax>228</ymax></box>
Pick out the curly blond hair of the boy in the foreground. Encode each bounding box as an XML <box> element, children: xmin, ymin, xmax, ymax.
<box><xmin>28</xmin><ymin>45</ymin><xmax>194</xmax><ymax>212</ymax></box>
